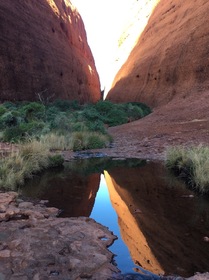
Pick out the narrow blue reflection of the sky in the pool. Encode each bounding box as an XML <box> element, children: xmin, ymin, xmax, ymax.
<box><xmin>90</xmin><ymin>175</ymin><xmax>139</xmax><ymax>273</ymax></box>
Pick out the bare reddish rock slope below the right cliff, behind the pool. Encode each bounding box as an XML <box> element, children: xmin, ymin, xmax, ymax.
<box><xmin>99</xmin><ymin>92</ymin><xmax>209</xmax><ymax>160</ymax></box>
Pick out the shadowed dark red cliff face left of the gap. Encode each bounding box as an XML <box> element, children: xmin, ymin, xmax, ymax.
<box><xmin>0</xmin><ymin>0</ymin><xmax>100</xmax><ymax>103</ymax></box>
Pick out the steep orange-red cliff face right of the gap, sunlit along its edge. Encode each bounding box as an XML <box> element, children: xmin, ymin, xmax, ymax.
<box><xmin>107</xmin><ymin>0</ymin><xmax>209</xmax><ymax>107</ymax></box>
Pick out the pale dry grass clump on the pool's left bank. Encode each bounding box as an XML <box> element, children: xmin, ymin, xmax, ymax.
<box><xmin>0</xmin><ymin>140</ymin><xmax>64</xmax><ymax>190</ymax></box>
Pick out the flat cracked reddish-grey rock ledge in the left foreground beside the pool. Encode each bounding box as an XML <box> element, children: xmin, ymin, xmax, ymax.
<box><xmin>0</xmin><ymin>192</ymin><xmax>118</xmax><ymax>280</ymax></box>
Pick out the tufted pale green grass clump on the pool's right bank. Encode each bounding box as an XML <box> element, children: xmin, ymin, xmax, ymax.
<box><xmin>166</xmin><ymin>145</ymin><xmax>209</xmax><ymax>193</ymax></box>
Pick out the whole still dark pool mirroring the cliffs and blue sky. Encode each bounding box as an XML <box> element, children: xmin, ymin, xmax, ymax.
<box><xmin>21</xmin><ymin>158</ymin><xmax>209</xmax><ymax>277</ymax></box>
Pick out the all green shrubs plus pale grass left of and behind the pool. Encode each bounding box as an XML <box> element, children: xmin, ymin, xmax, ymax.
<box><xmin>0</xmin><ymin>100</ymin><xmax>151</xmax><ymax>189</ymax></box>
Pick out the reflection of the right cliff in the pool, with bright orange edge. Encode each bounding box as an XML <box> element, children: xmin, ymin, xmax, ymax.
<box><xmin>105</xmin><ymin>163</ymin><xmax>209</xmax><ymax>277</ymax></box>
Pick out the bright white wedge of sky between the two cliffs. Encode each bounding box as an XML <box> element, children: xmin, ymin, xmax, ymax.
<box><xmin>71</xmin><ymin>0</ymin><xmax>128</xmax><ymax>89</ymax></box>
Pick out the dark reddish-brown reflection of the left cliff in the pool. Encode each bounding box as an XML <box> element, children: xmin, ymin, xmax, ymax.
<box><xmin>21</xmin><ymin>167</ymin><xmax>100</xmax><ymax>217</ymax></box>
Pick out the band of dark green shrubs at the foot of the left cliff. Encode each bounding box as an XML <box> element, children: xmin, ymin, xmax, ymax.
<box><xmin>0</xmin><ymin>100</ymin><xmax>151</xmax><ymax>147</ymax></box>
